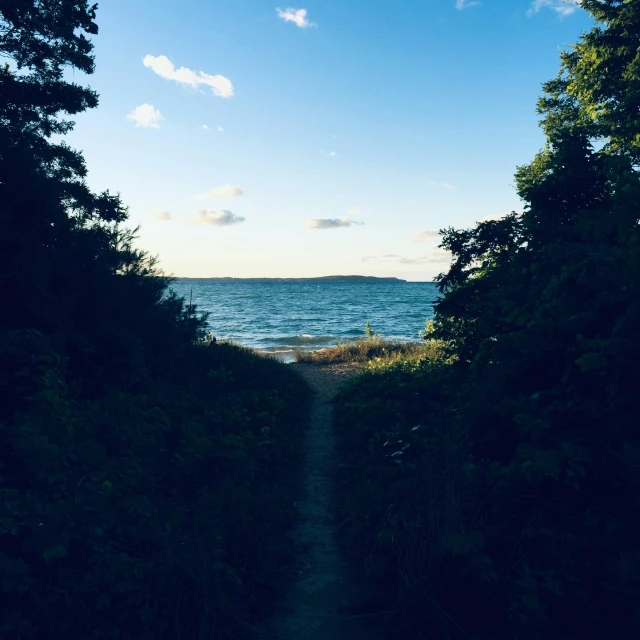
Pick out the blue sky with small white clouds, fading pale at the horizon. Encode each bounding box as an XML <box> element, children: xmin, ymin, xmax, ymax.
<box><xmin>62</xmin><ymin>0</ymin><xmax>592</xmax><ymax>281</ymax></box>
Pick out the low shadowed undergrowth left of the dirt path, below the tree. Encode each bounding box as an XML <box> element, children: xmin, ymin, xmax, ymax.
<box><xmin>0</xmin><ymin>338</ymin><xmax>309</xmax><ymax>639</ymax></box>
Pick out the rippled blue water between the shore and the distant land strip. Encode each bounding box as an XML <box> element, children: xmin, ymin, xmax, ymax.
<box><xmin>171</xmin><ymin>278</ymin><xmax>438</xmax><ymax>361</ymax></box>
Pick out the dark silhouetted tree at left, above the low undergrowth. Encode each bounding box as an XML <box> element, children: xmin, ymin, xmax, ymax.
<box><xmin>0</xmin><ymin>0</ymin><xmax>202</xmax><ymax>392</ymax></box>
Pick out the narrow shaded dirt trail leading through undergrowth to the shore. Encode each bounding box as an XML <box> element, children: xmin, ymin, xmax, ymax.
<box><xmin>264</xmin><ymin>364</ymin><xmax>380</xmax><ymax>640</ymax></box>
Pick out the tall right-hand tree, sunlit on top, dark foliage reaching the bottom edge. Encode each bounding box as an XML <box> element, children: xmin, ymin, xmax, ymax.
<box><xmin>432</xmin><ymin>0</ymin><xmax>640</xmax><ymax>638</ymax></box>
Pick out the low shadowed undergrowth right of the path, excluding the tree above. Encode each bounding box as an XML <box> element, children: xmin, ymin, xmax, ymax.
<box><xmin>334</xmin><ymin>336</ymin><xmax>640</xmax><ymax>640</ymax></box>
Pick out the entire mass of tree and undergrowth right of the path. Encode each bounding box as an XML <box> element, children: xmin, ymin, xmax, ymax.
<box><xmin>337</xmin><ymin>0</ymin><xmax>640</xmax><ymax>640</ymax></box>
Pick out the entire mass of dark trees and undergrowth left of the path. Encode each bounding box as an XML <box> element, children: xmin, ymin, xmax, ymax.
<box><xmin>0</xmin><ymin>0</ymin><xmax>308</xmax><ymax>640</ymax></box>
